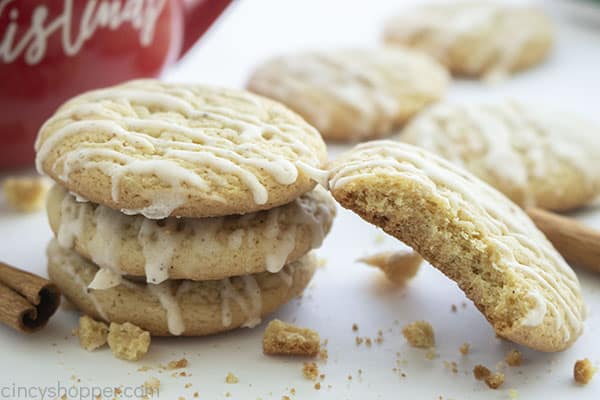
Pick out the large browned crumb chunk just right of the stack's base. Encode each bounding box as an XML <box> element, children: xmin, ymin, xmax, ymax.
<box><xmin>263</xmin><ymin>319</ymin><xmax>321</xmax><ymax>357</ymax></box>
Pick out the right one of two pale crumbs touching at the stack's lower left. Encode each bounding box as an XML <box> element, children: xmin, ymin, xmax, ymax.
<box><xmin>107</xmin><ymin>322</ymin><xmax>150</xmax><ymax>361</ymax></box>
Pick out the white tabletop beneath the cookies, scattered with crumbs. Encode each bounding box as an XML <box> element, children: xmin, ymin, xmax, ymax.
<box><xmin>0</xmin><ymin>0</ymin><xmax>600</xmax><ymax>400</ymax></box>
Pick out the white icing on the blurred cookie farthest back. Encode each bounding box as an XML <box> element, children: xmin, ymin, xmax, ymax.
<box><xmin>385</xmin><ymin>1</ymin><xmax>540</xmax><ymax>81</ymax></box>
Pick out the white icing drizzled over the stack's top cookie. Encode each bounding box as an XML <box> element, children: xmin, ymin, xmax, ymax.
<box><xmin>36</xmin><ymin>81</ymin><xmax>321</xmax><ymax>219</ymax></box>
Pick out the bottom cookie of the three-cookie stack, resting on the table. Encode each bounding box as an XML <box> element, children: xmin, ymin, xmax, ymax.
<box><xmin>48</xmin><ymin>240</ymin><xmax>316</xmax><ymax>336</ymax></box>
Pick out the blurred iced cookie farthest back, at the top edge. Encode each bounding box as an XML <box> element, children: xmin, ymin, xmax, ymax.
<box><xmin>384</xmin><ymin>1</ymin><xmax>553</xmax><ymax>78</ymax></box>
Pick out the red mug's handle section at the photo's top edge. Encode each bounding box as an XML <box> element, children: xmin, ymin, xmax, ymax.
<box><xmin>179</xmin><ymin>0</ymin><xmax>231</xmax><ymax>58</ymax></box>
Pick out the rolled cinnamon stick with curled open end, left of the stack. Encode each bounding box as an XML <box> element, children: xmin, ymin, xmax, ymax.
<box><xmin>0</xmin><ymin>262</ymin><xmax>60</xmax><ymax>333</ymax></box>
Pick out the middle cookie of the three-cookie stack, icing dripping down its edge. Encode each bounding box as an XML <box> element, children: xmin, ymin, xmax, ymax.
<box><xmin>47</xmin><ymin>185</ymin><xmax>335</xmax><ymax>284</ymax></box>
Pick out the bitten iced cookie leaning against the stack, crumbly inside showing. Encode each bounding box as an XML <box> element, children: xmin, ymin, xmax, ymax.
<box><xmin>330</xmin><ymin>141</ymin><xmax>585</xmax><ymax>351</ymax></box>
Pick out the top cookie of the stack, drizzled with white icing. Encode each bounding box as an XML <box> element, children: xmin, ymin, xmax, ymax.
<box><xmin>36</xmin><ymin>80</ymin><xmax>327</xmax><ymax>219</ymax></box>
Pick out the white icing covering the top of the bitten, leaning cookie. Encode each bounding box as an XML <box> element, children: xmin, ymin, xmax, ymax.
<box><xmin>330</xmin><ymin>141</ymin><xmax>585</xmax><ymax>342</ymax></box>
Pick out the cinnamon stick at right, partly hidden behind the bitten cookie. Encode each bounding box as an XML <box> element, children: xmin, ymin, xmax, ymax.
<box><xmin>526</xmin><ymin>208</ymin><xmax>600</xmax><ymax>272</ymax></box>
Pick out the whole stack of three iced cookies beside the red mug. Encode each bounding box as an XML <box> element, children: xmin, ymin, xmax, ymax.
<box><xmin>36</xmin><ymin>80</ymin><xmax>335</xmax><ymax>336</ymax></box>
